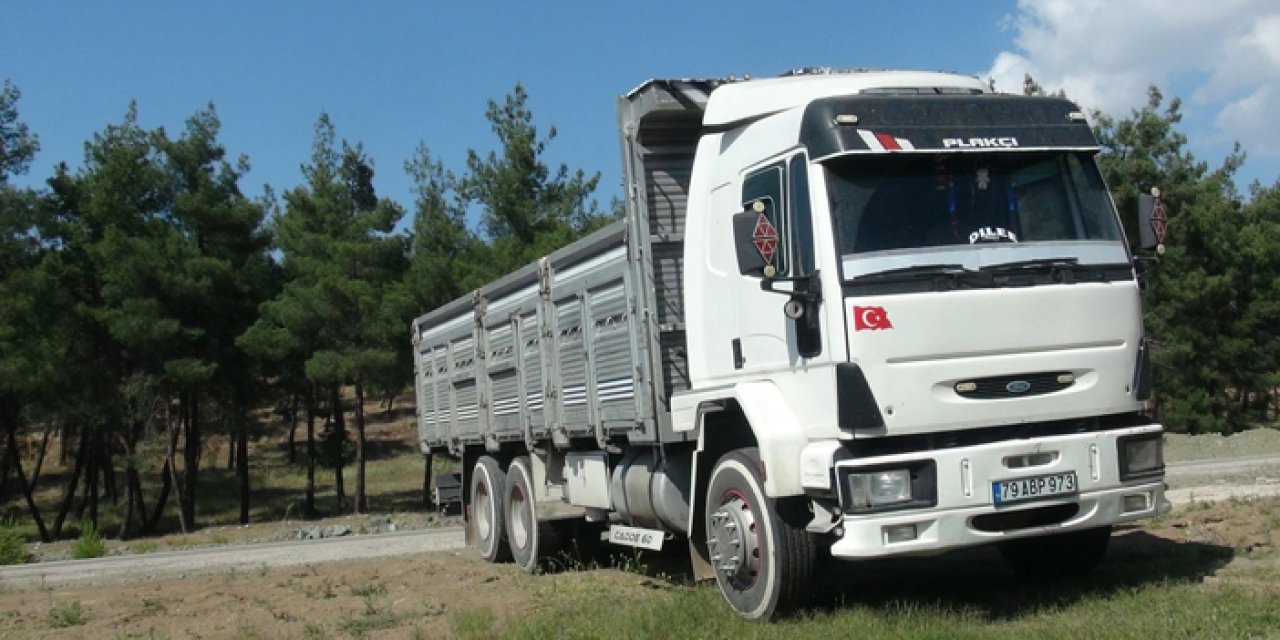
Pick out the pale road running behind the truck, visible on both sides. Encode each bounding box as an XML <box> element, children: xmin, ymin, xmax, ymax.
<box><xmin>0</xmin><ymin>456</ymin><xmax>1280</xmax><ymax>588</ymax></box>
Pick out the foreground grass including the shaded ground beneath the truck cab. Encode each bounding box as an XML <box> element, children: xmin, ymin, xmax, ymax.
<box><xmin>483</xmin><ymin>509</ymin><xmax>1280</xmax><ymax>640</ymax></box>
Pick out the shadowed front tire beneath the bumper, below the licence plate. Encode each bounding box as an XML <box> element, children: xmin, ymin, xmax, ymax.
<box><xmin>1000</xmin><ymin>526</ymin><xmax>1111</xmax><ymax>580</ymax></box>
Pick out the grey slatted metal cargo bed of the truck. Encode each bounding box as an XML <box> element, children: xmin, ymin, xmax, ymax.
<box><xmin>412</xmin><ymin>81</ymin><xmax>714</xmax><ymax>456</ymax></box>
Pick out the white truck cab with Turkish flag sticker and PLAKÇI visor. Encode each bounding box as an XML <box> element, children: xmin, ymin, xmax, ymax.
<box><xmin>672</xmin><ymin>73</ymin><xmax>1169</xmax><ymax>614</ymax></box>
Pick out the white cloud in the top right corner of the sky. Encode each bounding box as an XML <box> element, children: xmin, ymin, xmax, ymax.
<box><xmin>987</xmin><ymin>0</ymin><xmax>1280</xmax><ymax>155</ymax></box>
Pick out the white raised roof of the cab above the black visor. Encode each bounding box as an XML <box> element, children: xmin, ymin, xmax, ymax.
<box><xmin>703</xmin><ymin>70</ymin><xmax>988</xmax><ymax>127</ymax></box>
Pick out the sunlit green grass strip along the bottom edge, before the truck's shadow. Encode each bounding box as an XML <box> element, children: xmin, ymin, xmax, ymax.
<box><xmin>491</xmin><ymin>580</ymin><xmax>1280</xmax><ymax>640</ymax></box>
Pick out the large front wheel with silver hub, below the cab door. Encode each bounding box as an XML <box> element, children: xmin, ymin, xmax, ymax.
<box><xmin>704</xmin><ymin>448</ymin><xmax>817</xmax><ymax>620</ymax></box>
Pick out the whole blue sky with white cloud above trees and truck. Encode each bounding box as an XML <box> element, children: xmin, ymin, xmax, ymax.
<box><xmin>0</xmin><ymin>0</ymin><xmax>1280</xmax><ymax>217</ymax></box>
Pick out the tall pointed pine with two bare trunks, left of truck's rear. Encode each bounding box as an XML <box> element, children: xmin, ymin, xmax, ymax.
<box><xmin>244</xmin><ymin>114</ymin><xmax>407</xmax><ymax>512</ymax></box>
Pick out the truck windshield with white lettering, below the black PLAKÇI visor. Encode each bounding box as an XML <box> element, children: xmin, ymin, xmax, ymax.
<box><xmin>826</xmin><ymin>151</ymin><xmax>1121</xmax><ymax>259</ymax></box>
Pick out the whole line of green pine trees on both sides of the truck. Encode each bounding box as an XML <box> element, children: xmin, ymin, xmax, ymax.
<box><xmin>0</xmin><ymin>78</ymin><xmax>1280</xmax><ymax>540</ymax></box>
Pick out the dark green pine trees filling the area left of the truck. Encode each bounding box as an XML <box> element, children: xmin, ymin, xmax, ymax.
<box><xmin>0</xmin><ymin>82</ymin><xmax>609</xmax><ymax>540</ymax></box>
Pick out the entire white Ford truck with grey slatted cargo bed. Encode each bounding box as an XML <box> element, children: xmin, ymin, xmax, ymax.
<box><xmin>412</xmin><ymin>72</ymin><xmax>1169</xmax><ymax>618</ymax></box>
